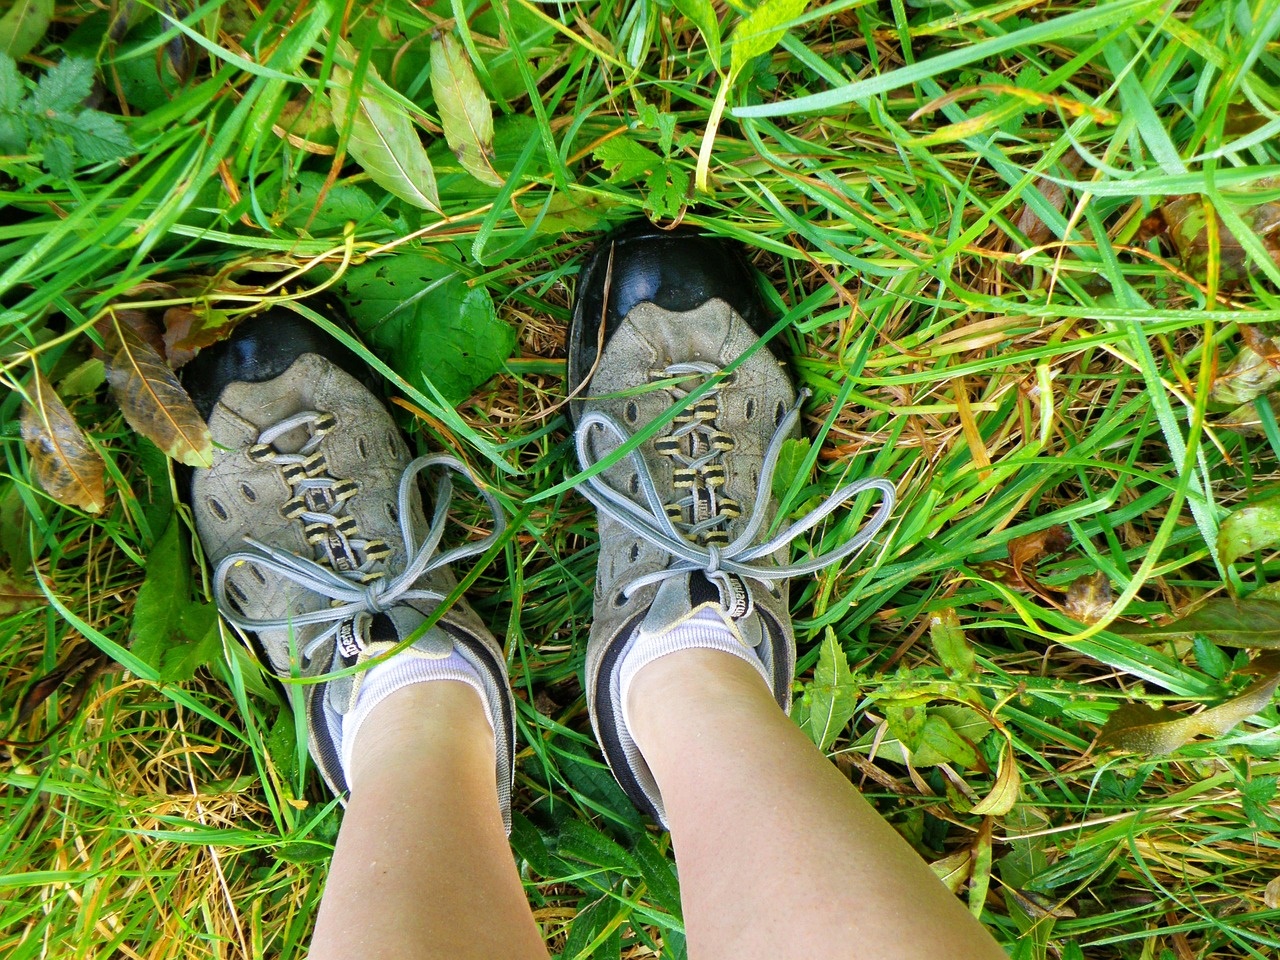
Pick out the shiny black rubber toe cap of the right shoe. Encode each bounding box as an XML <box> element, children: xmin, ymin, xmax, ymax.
<box><xmin>568</xmin><ymin>220</ymin><xmax>774</xmax><ymax>407</ymax></box>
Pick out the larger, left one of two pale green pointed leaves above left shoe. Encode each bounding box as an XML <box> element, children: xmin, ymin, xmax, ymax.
<box><xmin>329</xmin><ymin>41</ymin><xmax>440</xmax><ymax>212</ymax></box>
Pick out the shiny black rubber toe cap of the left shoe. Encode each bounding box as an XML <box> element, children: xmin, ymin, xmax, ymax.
<box><xmin>180</xmin><ymin>307</ymin><xmax>374</xmax><ymax>420</ymax></box>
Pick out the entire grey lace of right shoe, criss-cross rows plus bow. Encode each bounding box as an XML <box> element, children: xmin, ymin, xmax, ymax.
<box><xmin>575</xmin><ymin>378</ymin><xmax>896</xmax><ymax>617</ymax></box>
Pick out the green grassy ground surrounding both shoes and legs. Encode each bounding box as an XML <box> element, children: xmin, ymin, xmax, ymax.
<box><xmin>0</xmin><ymin>0</ymin><xmax>1280</xmax><ymax>960</ymax></box>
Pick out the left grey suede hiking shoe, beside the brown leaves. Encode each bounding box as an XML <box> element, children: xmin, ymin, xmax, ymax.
<box><xmin>183</xmin><ymin>308</ymin><xmax>515</xmax><ymax>829</ymax></box>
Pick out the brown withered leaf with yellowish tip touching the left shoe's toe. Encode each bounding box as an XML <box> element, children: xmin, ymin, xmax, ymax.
<box><xmin>106</xmin><ymin>313</ymin><xmax>214</xmax><ymax>467</ymax></box>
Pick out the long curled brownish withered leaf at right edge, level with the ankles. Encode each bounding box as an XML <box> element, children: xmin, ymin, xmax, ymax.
<box><xmin>1098</xmin><ymin>654</ymin><xmax>1280</xmax><ymax>755</ymax></box>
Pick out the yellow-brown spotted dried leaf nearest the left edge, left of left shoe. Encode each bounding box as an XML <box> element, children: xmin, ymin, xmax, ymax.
<box><xmin>22</xmin><ymin>370</ymin><xmax>106</xmax><ymax>513</ymax></box>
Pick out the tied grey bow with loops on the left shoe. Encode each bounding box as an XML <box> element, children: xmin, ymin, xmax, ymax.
<box><xmin>214</xmin><ymin>453</ymin><xmax>507</xmax><ymax>658</ymax></box>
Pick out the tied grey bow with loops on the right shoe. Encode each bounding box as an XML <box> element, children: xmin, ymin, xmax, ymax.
<box><xmin>575</xmin><ymin>390</ymin><xmax>896</xmax><ymax>616</ymax></box>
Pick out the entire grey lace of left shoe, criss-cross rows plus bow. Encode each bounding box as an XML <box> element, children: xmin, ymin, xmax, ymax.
<box><xmin>212</xmin><ymin>412</ymin><xmax>506</xmax><ymax>659</ymax></box>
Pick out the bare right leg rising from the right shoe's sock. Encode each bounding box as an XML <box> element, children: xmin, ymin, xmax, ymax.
<box><xmin>628</xmin><ymin>649</ymin><xmax>1005</xmax><ymax>960</ymax></box>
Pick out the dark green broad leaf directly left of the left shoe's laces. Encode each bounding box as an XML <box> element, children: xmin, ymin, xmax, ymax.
<box><xmin>129</xmin><ymin>515</ymin><xmax>221</xmax><ymax>682</ymax></box>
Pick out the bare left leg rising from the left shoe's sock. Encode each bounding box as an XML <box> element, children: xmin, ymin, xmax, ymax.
<box><xmin>310</xmin><ymin>680</ymin><xmax>547</xmax><ymax>960</ymax></box>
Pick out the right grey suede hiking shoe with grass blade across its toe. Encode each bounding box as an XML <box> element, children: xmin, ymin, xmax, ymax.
<box><xmin>568</xmin><ymin>224</ymin><xmax>895</xmax><ymax>824</ymax></box>
